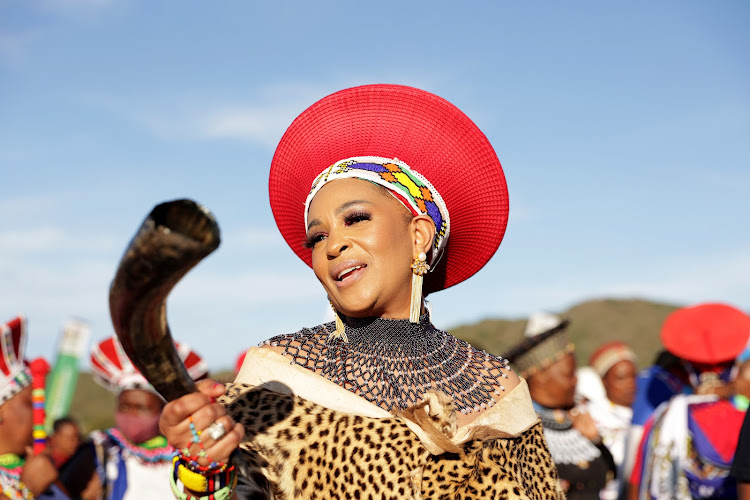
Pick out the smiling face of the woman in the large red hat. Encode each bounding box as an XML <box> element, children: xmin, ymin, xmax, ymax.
<box><xmin>307</xmin><ymin>179</ymin><xmax>424</xmax><ymax>318</ymax></box>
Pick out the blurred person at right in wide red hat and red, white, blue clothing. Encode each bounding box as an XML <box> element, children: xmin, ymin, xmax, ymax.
<box><xmin>630</xmin><ymin>304</ymin><xmax>750</xmax><ymax>499</ymax></box>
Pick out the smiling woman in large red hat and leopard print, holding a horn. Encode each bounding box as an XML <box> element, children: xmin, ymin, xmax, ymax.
<box><xmin>161</xmin><ymin>85</ymin><xmax>558</xmax><ymax>498</ymax></box>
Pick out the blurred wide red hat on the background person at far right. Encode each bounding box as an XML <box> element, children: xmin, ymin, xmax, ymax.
<box><xmin>661</xmin><ymin>304</ymin><xmax>750</xmax><ymax>364</ymax></box>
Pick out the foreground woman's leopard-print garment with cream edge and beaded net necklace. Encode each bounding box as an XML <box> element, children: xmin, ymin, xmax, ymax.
<box><xmin>222</xmin><ymin>316</ymin><xmax>562</xmax><ymax>499</ymax></box>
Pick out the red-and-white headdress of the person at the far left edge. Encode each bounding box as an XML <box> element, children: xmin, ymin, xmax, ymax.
<box><xmin>0</xmin><ymin>316</ymin><xmax>32</xmax><ymax>405</ymax></box>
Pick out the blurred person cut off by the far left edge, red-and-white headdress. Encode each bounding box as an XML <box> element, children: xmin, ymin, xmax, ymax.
<box><xmin>0</xmin><ymin>316</ymin><xmax>57</xmax><ymax>499</ymax></box>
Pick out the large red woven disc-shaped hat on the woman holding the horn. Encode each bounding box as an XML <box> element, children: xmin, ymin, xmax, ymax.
<box><xmin>269</xmin><ymin>84</ymin><xmax>508</xmax><ymax>294</ymax></box>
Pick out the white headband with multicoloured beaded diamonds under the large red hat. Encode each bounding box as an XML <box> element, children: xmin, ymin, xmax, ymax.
<box><xmin>305</xmin><ymin>156</ymin><xmax>450</xmax><ymax>269</ymax></box>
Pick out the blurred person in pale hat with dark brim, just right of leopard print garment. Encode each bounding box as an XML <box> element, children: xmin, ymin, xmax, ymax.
<box><xmin>506</xmin><ymin>313</ymin><xmax>615</xmax><ymax>500</ymax></box>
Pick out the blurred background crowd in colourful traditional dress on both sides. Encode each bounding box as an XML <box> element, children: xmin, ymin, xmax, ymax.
<box><xmin>0</xmin><ymin>304</ymin><xmax>750</xmax><ymax>500</ymax></box>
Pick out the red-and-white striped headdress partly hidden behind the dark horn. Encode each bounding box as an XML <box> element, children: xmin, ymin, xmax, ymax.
<box><xmin>91</xmin><ymin>337</ymin><xmax>208</xmax><ymax>394</ymax></box>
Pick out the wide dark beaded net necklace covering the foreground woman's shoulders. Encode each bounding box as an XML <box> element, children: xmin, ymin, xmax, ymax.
<box><xmin>262</xmin><ymin>314</ymin><xmax>508</xmax><ymax>414</ymax></box>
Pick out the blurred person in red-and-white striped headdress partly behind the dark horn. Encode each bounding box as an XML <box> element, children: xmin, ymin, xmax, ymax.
<box><xmin>89</xmin><ymin>338</ymin><xmax>208</xmax><ymax>500</ymax></box>
